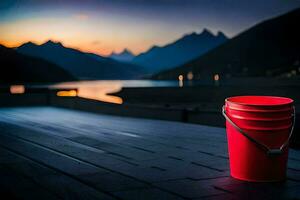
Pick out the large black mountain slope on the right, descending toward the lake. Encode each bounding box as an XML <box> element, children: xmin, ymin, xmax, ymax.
<box><xmin>154</xmin><ymin>9</ymin><xmax>300</xmax><ymax>79</ymax></box>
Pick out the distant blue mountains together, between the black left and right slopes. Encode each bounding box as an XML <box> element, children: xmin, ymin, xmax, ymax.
<box><xmin>10</xmin><ymin>29</ymin><xmax>227</xmax><ymax>80</ymax></box>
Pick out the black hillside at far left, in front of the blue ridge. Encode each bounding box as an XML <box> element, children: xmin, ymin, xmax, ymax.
<box><xmin>0</xmin><ymin>45</ymin><xmax>76</xmax><ymax>84</ymax></box>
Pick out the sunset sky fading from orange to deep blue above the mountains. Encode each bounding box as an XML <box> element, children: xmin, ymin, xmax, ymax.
<box><xmin>0</xmin><ymin>0</ymin><xmax>300</xmax><ymax>55</ymax></box>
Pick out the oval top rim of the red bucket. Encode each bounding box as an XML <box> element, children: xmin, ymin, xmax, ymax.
<box><xmin>225</xmin><ymin>95</ymin><xmax>294</xmax><ymax>107</ymax></box>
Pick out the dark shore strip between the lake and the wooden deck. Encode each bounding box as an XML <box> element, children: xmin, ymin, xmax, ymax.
<box><xmin>0</xmin><ymin>86</ymin><xmax>300</xmax><ymax>147</ymax></box>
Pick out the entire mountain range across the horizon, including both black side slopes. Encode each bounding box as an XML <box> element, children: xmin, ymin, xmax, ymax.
<box><xmin>1</xmin><ymin>6</ymin><xmax>300</xmax><ymax>82</ymax></box>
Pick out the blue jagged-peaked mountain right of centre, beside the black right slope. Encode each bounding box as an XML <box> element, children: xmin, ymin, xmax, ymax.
<box><xmin>132</xmin><ymin>29</ymin><xmax>227</xmax><ymax>72</ymax></box>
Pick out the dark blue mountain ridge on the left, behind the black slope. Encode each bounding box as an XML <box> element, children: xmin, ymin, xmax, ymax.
<box><xmin>17</xmin><ymin>40</ymin><xmax>144</xmax><ymax>79</ymax></box>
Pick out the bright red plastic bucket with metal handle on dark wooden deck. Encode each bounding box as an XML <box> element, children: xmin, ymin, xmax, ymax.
<box><xmin>223</xmin><ymin>96</ymin><xmax>295</xmax><ymax>182</ymax></box>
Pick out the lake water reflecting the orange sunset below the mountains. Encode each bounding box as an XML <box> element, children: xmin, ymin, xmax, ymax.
<box><xmin>10</xmin><ymin>78</ymin><xmax>300</xmax><ymax>104</ymax></box>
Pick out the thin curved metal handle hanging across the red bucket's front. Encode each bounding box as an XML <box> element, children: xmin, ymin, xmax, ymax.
<box><xmin>222</xmin><ymin>106</ymin><xmax>296</xmax><ymax>156</ymax></box>
